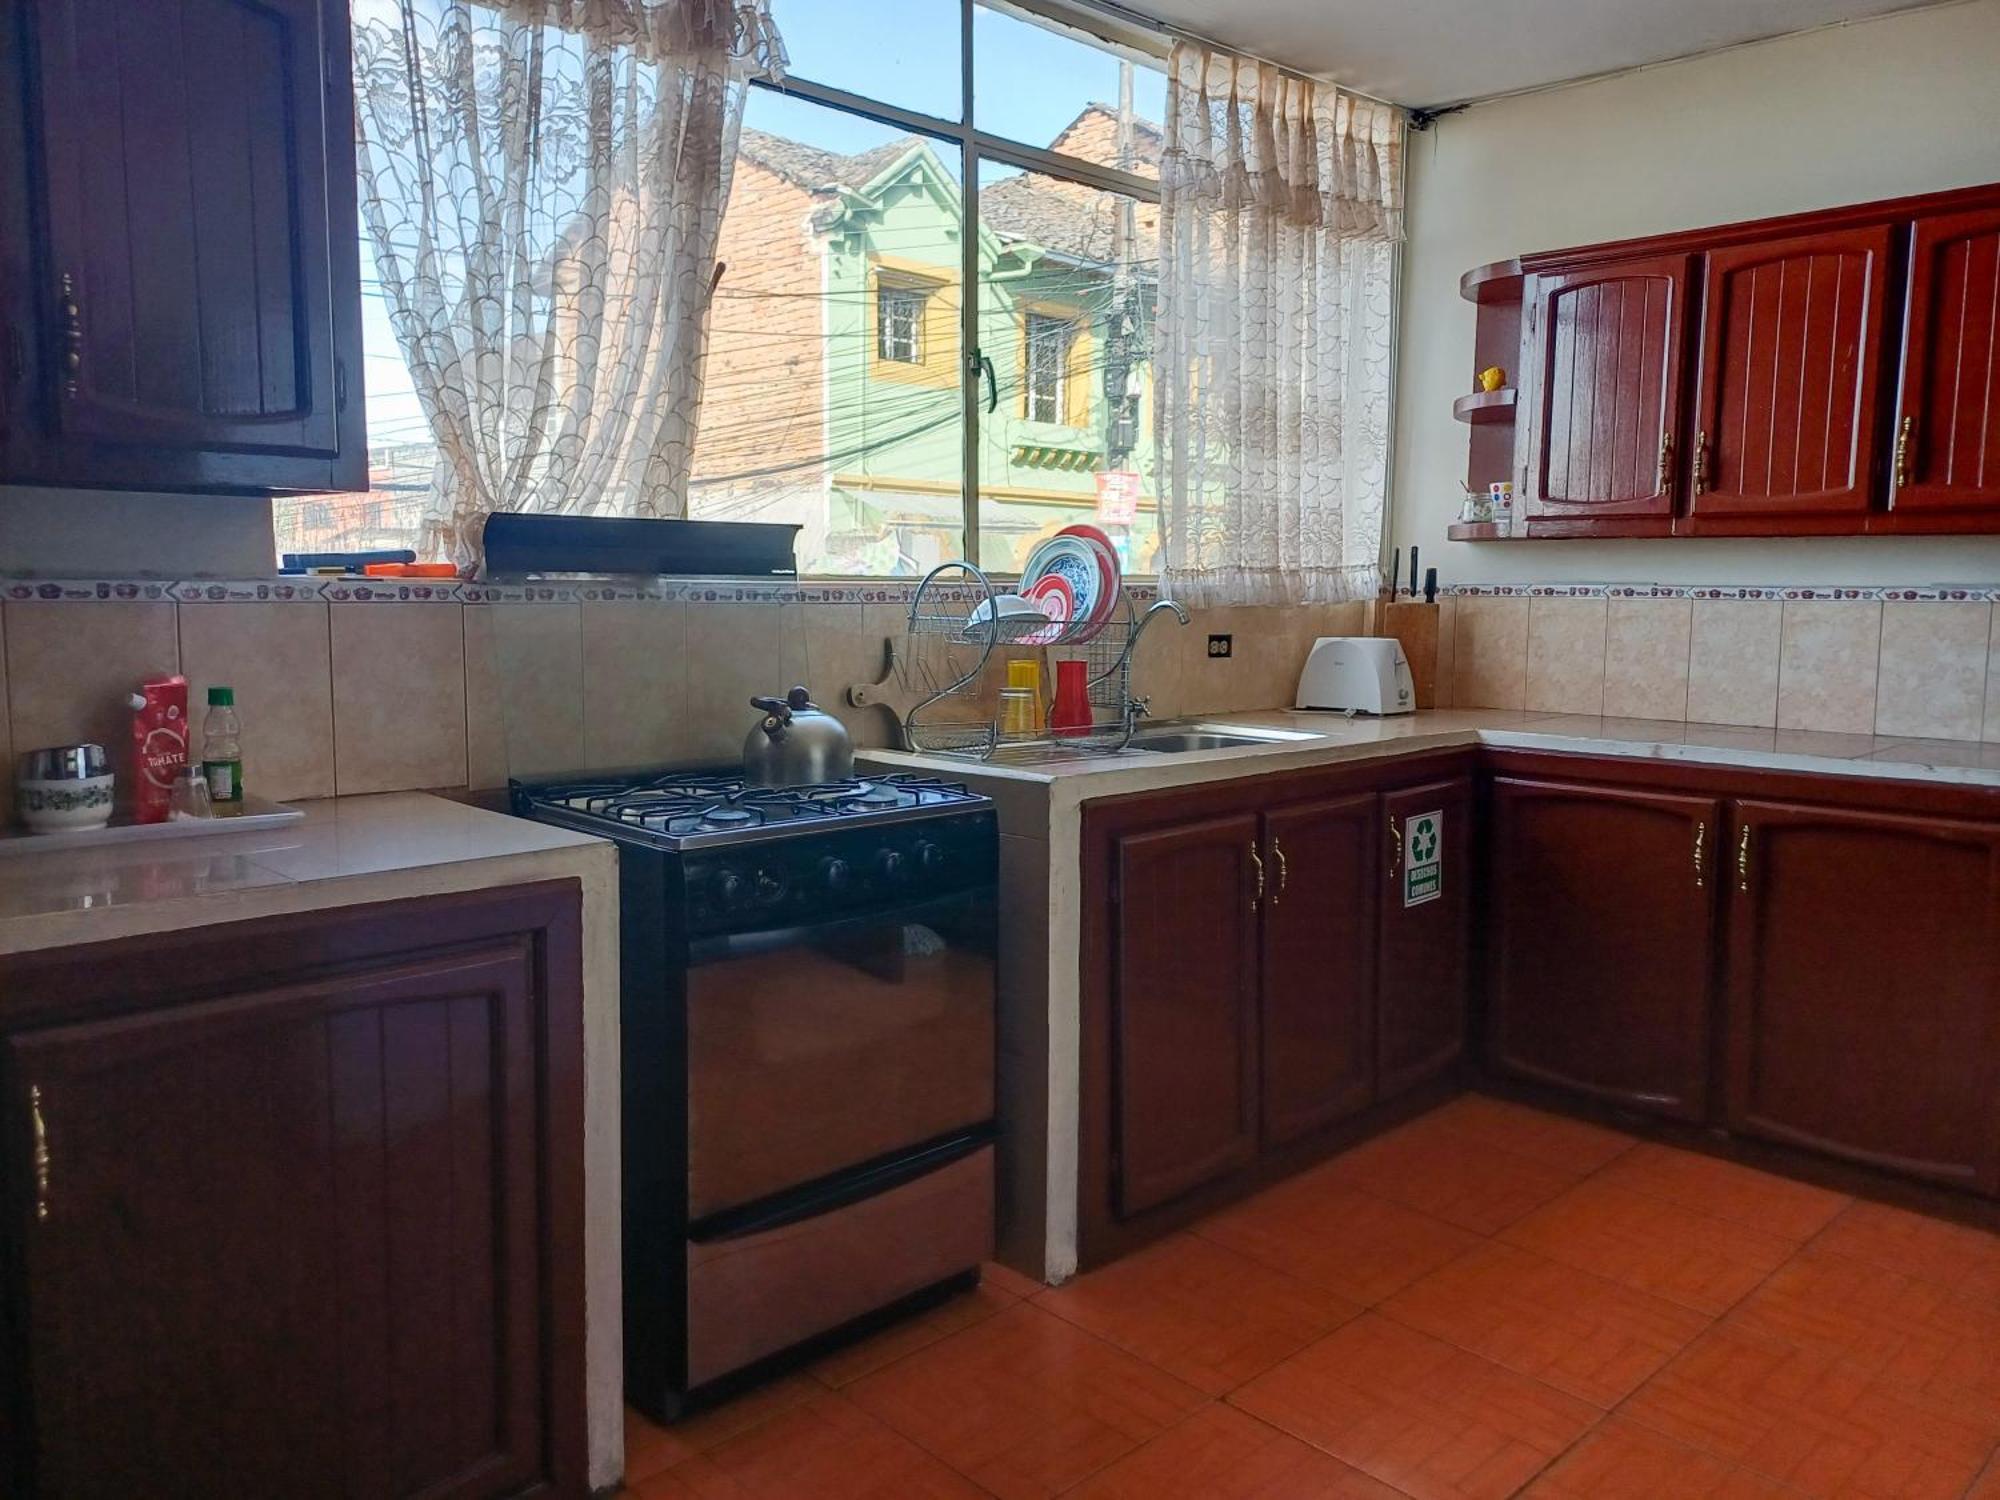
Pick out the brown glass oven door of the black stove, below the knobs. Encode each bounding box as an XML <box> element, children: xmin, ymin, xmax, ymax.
<box><xmin>688</xmin><ymin>886</ymin><xmax>994</xmax><ymax>1238</ymax></box>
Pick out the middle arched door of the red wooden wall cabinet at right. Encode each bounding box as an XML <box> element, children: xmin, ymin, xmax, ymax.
<box><xmin>1688</xmin><ymin>224</ymin><xmax>1890</xmax><ymax>530</ymax></box>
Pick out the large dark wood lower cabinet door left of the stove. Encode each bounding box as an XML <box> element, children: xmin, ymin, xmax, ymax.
<box><xmin>4</xmin><ymin>938</ymin><xmax>552</xmax><ymax>1500</ymax></box>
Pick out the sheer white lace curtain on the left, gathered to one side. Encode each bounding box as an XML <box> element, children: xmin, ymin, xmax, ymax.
<box><xmin>354</xmin><ymin>0</ymin><xmax>784</xmax><ymax>566</ymax></box>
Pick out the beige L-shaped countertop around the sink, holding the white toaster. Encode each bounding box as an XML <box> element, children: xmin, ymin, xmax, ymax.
<box><xmin>864</xmin><ymin>708</ymin><xmax>2000</xmax><ymax>804</ymax></box>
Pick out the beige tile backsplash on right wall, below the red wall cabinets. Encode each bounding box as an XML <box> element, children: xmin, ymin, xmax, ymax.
<box><xmin>1442</xmin><ymin>584</ymin><xmax>2000</xmax><ymax>740</ymax></box>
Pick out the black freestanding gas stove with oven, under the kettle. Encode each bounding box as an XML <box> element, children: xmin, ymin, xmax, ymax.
<box><xmin>512</xmin><ymin>770</ymin><xmax>998</xmax><ymax>1418</ymax></box>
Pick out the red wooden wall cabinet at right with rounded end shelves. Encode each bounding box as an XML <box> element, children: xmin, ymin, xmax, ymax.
<box><xmin>1458</xmin><ymin>184</ymin><xmax>2000</xmax><ymax>536</ymax></box>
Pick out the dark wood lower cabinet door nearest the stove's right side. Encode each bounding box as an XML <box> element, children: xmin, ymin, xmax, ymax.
<box><xmin>1112</xmin><ymin>812</ymin><xmax>1260</xmax><ymax>1218</ymax></box>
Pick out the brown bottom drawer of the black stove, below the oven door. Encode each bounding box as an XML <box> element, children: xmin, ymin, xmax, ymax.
<box><xmin>688</xmin><ymin>1146</ymin><xmax>994</xmax><ymax>1386</ymax></box>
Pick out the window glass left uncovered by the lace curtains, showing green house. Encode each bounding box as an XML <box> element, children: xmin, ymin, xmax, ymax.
<box><xmin>294</xmin><ymin>0</ymin><xmax>1166</xmax><ymax>576</ymax></box>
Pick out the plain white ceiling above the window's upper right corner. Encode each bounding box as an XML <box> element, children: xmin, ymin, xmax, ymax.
<box><xmin>1126</xmin><ymin>0</ymin><xmax>1960</xmax><ymax>106</ymax></box>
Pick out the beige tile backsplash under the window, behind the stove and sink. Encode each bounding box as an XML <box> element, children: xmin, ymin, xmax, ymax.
<box><xmin>0</xmin><ymin>582</ymin><xmax>1364</xmax><ymax>818</ymax></box>
